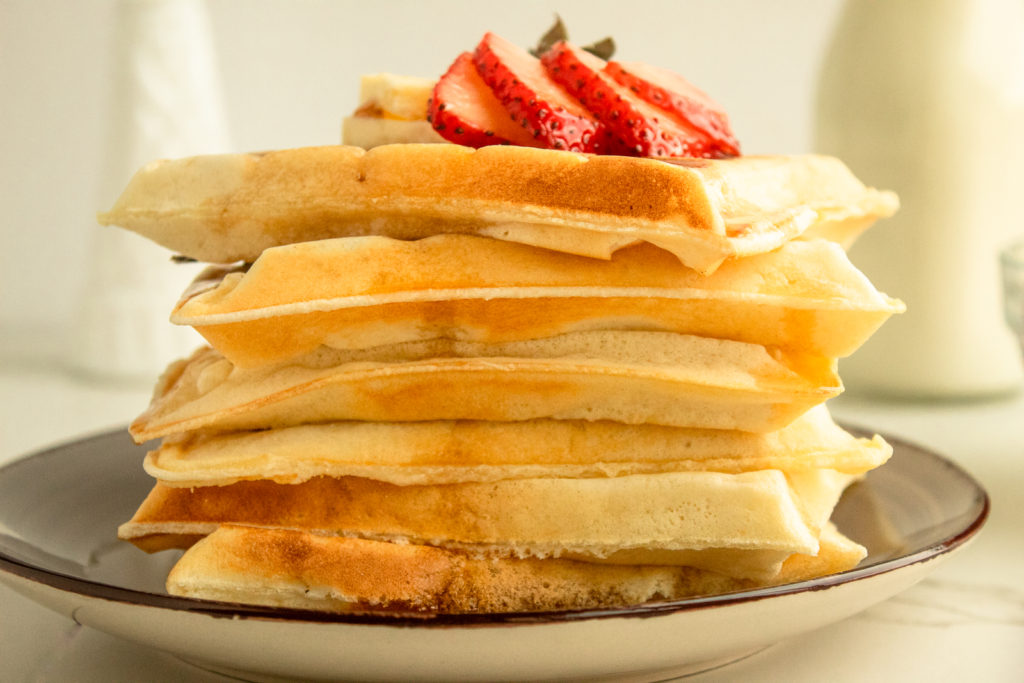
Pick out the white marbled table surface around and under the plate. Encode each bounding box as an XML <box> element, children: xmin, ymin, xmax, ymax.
<box><xmin>0</xmin><ymin>367</ymin><xmax>1024</xmax><ymax>683</ymax></box>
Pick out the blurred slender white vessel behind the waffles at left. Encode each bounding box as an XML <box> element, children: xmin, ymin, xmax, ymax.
<box><xmin>67</xmin><ymin>0</ymin><xmax>229</xmax><ymax>384</ymax></box>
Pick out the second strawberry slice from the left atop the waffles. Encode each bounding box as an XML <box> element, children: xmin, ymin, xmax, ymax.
<box><xmin>473</xmin><ymin>33</ymin><xmax>607</xmax><ymax>154</ymax></box>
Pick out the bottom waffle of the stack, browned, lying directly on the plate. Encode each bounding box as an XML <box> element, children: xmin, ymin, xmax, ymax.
<box><xmin>167</xmin><ymin>524</ymin><xmax>864</xmax><ymax>613</ymax></box>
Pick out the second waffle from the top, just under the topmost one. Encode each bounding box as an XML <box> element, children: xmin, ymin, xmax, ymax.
<box><xmin>171</xmin><ymin>234</ymin><xmax>902</xmax><ymax>367</ymax></box>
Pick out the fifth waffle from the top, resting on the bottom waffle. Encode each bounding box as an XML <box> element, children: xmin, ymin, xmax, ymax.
<box><xmin>119</xmin><ymin>469</ymin><xmax>853</xmax><ymax>581</ymax></box>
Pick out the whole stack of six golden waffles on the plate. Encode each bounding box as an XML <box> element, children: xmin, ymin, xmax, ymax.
<box><xmin>103</xmin><ymin>136</ymin><xmax>902</xmax><ymax>612</ymax></box>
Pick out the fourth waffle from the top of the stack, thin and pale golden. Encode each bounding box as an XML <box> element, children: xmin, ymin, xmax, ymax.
<box><xmin>145</xmin><ymin>405</ymin><xmax>892</xmax><ymax>486</ymax></box>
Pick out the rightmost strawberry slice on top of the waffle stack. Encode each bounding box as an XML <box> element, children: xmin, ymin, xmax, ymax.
<box><xmin>605</xmin><ymin>61</ymin><xmax>739</xmax><ymax>157</ymax></box>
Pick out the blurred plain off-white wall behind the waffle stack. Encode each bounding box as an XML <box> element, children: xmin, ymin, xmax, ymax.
<box><xmin>0</xmin><ymin>0</ymin><xmax>842</xmax><ymax>376</ymax></box>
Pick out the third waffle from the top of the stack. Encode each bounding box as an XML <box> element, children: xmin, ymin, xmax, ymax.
<box><xmin>131</xmin><ymin>332</ymin><xmax>842</xmax><ymax>442</ymax></box>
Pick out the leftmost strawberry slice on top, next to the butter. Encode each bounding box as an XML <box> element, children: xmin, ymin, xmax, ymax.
<box><xmin>427</xmin><ymin>52</ymin><xmax>541</xmax><ymax>147</ymax></box>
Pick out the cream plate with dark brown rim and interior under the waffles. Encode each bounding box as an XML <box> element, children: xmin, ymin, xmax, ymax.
<box><xmin>0</xmin><ymin>423</ymin><xmax>988</xmax><ymax>681</ymax></box>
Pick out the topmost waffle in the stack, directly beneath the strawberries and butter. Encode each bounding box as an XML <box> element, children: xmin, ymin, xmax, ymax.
<box><xmin>99</xmin><ymin>144</ymin><xmax>897</xmax><ymax>273</ymax></box>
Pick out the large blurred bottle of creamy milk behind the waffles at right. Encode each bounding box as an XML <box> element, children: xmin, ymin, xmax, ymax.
<box><xmin>815</xmin><ymin>0</ymin><xmax>1024</xmax><ymax>397</ymax></box>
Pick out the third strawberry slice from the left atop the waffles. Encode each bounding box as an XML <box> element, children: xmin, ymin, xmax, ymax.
<box><xmin>541</xmin><ymin>41</ymin><xmax>714</xmax><ymax>157</ymax></box>
